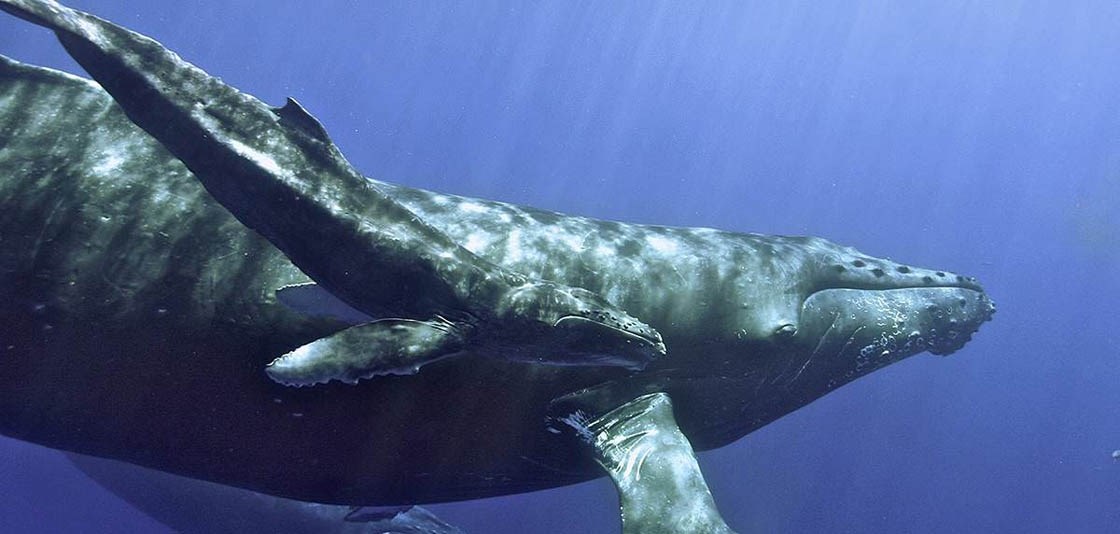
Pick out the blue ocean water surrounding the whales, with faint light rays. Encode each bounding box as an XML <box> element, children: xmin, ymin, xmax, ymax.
<box><xmin>0</xmin><ymin>0</ymin><xmax>1120</xmax><ymax>533</ymax></box>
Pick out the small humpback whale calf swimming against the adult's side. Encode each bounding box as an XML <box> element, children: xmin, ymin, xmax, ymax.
<box><xmin>0</xmin><ymin>0</ymin><xmax>665</xmax><ymax>385</ymax></box>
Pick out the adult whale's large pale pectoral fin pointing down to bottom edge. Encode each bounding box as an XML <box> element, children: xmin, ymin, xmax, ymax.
<box><xmin>564</xmin><ymin>393</ymin><xmax>734</xmax><ymax>534</ymax></box>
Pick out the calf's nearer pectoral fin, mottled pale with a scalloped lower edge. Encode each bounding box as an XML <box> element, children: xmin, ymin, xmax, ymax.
<box><xmin>265</xmin><ymin>319</ymin><xmax>464</xmax><ymax>386</ymax></box>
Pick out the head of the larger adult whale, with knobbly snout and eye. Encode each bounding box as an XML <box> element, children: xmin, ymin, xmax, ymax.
<box><xmin>735</xmin><ymin>237</ymin><xmax>996</xmax><ymax>384</ymax></box>
